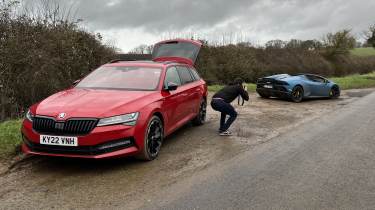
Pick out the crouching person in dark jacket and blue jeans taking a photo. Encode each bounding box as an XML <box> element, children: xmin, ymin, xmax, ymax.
<box><xmin>211</xmin><ymin>78</ymin><xmax>249</xmax><ymax>136</ymax></box>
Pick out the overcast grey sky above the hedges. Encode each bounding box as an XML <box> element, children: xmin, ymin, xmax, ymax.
<box><xmin>30</xmin><ymin>0</ymin><xmax>375</xmax><ymax>52</ymax></box>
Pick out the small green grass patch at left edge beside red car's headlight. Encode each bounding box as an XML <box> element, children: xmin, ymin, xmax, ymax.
<box><xmin>0</xmin><ymin>120</ymin><xmax>22</xmax><ymax>158</ymax></box>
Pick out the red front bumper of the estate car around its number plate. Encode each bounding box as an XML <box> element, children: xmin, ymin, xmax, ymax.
<box><xmin>22</xmin><ymin>120</ymin><xmax>143</xmax><ymax>159</ymax></box>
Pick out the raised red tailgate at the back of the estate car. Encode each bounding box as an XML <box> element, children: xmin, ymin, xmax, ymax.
<box><xmin>152</xmin><ymin>39</ymin><xmax>202</xmax><ymax>66</ymax></box>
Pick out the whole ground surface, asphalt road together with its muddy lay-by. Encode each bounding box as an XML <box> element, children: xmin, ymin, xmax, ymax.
<box><xmin>0</xmin><ymin>89</ymin><xmax>375</xmax><ymax>210</ymax></box>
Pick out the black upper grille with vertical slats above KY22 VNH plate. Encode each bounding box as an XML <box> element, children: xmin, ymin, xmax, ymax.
<box><xmin>33</xmin><ymin>117</ymin><xmax>98</xmax><ymax>135</ymax></box>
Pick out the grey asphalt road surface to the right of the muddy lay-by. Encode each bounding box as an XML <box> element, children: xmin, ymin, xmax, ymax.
<box><xmin>144</xmin><ymin>93</ymin><xmax>375</xmax><ymax>209</ymax></box>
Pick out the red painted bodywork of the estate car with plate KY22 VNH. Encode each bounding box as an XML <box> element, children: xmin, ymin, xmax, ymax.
<box><xmin>21</xmin><ymin>39</ymin><xmax>207</xmax><ymax>159</ymax></box>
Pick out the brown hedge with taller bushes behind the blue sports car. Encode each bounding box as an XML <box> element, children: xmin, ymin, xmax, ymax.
<box><xmin>197</xmin><ymin>36</ymin><xmax>375</xmax><ymax>84</ymax></box>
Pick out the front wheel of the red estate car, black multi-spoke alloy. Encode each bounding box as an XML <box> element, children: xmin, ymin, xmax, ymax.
<box><xmin>137</xmin><ymin>116</ymin><xmax>164</xmax><ymax>160</ymax></box>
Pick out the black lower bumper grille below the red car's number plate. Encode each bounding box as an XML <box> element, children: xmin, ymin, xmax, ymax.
<box><xmin>23</xmin><ymin>136</ymin><xmax>135</xmax><ymax>155</ymax></box>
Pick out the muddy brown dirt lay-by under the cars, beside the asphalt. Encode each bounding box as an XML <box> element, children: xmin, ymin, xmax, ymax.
<box><xmin>0</xmin><ymin>89</ymin><xmax>374</xmax><ymax>209</ymax></box>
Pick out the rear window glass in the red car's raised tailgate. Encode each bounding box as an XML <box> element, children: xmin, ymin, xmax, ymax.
<box><xmin>152</xmin><ymin>41</ymin><xmax>200</xmax><ymax>62</ymax></box>
